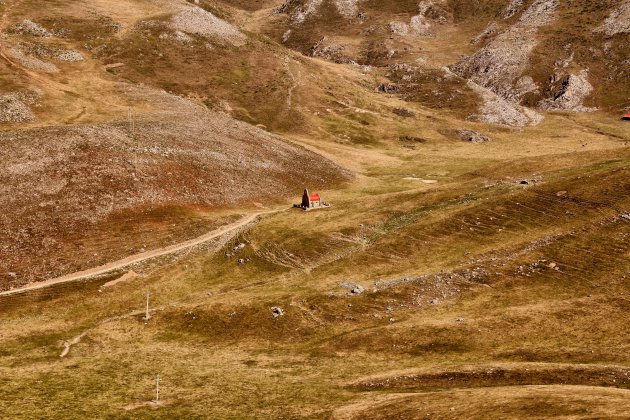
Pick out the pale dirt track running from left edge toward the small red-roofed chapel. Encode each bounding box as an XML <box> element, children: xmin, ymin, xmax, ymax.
<box><xmin>0</xmin><ymin>210</ymin><xmax>281</xmax><ymax>296</ymax></box>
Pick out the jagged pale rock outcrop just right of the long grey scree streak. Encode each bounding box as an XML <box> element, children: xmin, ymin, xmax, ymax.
<box><xmin>538</xmin><ymin>70</ymin><xmax>597</xmax><ymax>112</ymax></box>
